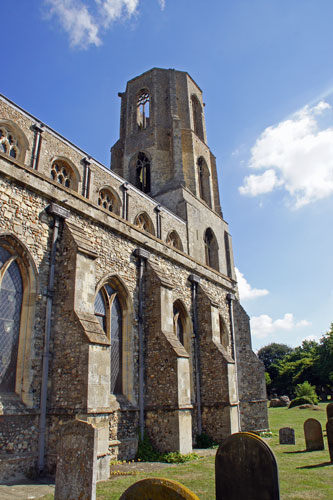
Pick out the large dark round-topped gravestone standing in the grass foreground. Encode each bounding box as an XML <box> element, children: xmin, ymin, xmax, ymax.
<box><xmin>215</xmin><ymin>432</ymin><xmax>280</xmax><ymax>500</ymax></box>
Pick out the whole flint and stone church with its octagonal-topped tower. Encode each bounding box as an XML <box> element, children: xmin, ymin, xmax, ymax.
<box><xmin>0</xmin><ymin>68</ymin><xmax>268</xmax><ymax>481</ymax></box>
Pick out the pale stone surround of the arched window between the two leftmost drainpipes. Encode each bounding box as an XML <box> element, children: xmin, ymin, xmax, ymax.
<box><xmin>95</xmin><ymin>275</ymin><xmax>134</xmax><ymax>402</ymax></box>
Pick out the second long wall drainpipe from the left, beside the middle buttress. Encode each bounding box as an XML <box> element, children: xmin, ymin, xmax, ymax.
<box><xmin>134</xmin><ymin>248</ymin><xmax>149</xmax><ymax>440</ymax></box>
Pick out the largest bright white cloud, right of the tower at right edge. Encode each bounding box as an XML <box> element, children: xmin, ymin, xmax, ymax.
<box><xmin>239</xmin><ymin>101</ymin><xmax>333</xmax><ymax>208</ymax></box>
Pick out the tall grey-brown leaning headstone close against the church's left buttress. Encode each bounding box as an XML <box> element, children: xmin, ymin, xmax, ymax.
<box><xmin>54</xmin><ymin>420</ymin><xmax>97</xmax><ymax>500</ymax></box>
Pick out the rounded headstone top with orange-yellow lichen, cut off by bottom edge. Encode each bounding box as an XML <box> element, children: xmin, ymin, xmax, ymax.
<box><xmin>119</xmin><ymin>478</ymin><xmax>199</xmax><ymax>500</ymax></box>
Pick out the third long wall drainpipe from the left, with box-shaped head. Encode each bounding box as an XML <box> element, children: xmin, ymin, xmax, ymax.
<box><xmin>189</xmin><ymin>274</ymin><xmax>202</xmax><ymax>436</ymax></box>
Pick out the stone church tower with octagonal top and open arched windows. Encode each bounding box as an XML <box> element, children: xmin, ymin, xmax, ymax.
<box><xmin>111</xmin><ymin>68</ymin><xmax>235</xmax><ymax>280</ymax></box>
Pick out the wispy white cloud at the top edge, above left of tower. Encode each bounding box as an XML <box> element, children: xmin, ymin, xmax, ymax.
<box><xmin>44</xmin><ymin>0</ymin><xmax>165</xmax><ymax>49</ymax></box>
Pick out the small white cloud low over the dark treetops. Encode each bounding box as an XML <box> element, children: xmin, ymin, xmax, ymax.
<box><xmin>250</xmin><ymin>313</ymin><xmax>310</xmax><ymax>338</ymax></box>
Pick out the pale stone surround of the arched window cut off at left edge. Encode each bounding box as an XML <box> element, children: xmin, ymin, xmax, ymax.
<box><xmin>0</xmin><ymin>233</ymin><xmax>38</xmax><ymax>406</ymax></box>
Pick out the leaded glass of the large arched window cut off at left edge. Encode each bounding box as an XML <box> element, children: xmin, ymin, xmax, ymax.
<box><xmin>0</xmin><ymin>246</ymin><xmax>23</xmax><ymax>392</ymax></box>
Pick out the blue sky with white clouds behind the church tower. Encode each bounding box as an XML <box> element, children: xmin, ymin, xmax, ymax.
<box><xmin>0</xmin><ymin>0</ymin><xmax>333</xmax><ymax>349</ymax></box>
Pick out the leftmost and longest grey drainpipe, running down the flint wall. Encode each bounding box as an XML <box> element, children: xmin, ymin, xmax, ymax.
<box><xmin>38</xmin><ymin>203</ymin><xmax>70</xmax><ymax>473</ymax></box>
